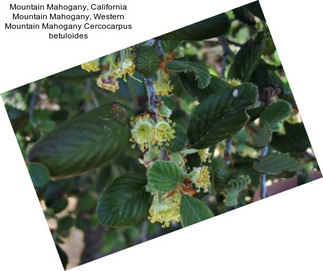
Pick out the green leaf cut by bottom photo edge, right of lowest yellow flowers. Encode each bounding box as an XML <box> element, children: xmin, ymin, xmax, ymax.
<box><xmin>180</xmin><ymin>194</ymin><xmax>213</xmax><ymax>227</ymax></box>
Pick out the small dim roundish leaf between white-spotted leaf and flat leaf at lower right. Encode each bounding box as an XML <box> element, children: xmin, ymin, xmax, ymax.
<box><xmin>248</xmin><ymin>122</ymin><xmax>272</xmax><ymax>148</ymax></box>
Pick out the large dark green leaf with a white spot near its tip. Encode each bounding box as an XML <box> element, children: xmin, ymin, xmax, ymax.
<box><xmin>187</xmin><ymin>84</ymin><xmax>258</xmax><ymax>149</ymax></box>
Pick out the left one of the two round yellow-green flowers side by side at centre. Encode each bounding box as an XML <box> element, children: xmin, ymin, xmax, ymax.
<box><xmin>131</xmin><ymin>115</ymin><xmax>155</xmax><ymax>152</ymax></box>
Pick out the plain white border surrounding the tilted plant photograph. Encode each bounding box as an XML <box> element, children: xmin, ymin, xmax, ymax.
<box><xmin>0</xmin><ymin>0</ymin><xmax>323</xmax><ymax>271</ymax></box>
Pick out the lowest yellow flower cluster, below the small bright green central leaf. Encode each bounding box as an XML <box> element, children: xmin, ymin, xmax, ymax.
<box><xmin>148</xmin><ymin>192</ymin><xmax>181</xmax><ymax>228</ymax></box>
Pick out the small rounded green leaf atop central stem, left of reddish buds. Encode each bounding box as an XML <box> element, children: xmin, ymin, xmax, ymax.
<box><xmin>136</xmin><ymin>46</ymin><xmax>159</xmax><ymax>77</ymax></box>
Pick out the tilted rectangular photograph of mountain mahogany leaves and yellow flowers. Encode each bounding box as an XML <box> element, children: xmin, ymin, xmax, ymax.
<box><xmin>1</xmin><ymin>1</ymin><xmax>322</xmax><ymax>269</ymax></box>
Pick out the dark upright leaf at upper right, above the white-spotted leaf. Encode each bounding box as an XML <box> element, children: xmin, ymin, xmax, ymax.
<box><xmin>228</xmin><ymin>36</ymin><xmax>265</xmax><ymax>82</ymax></box>
